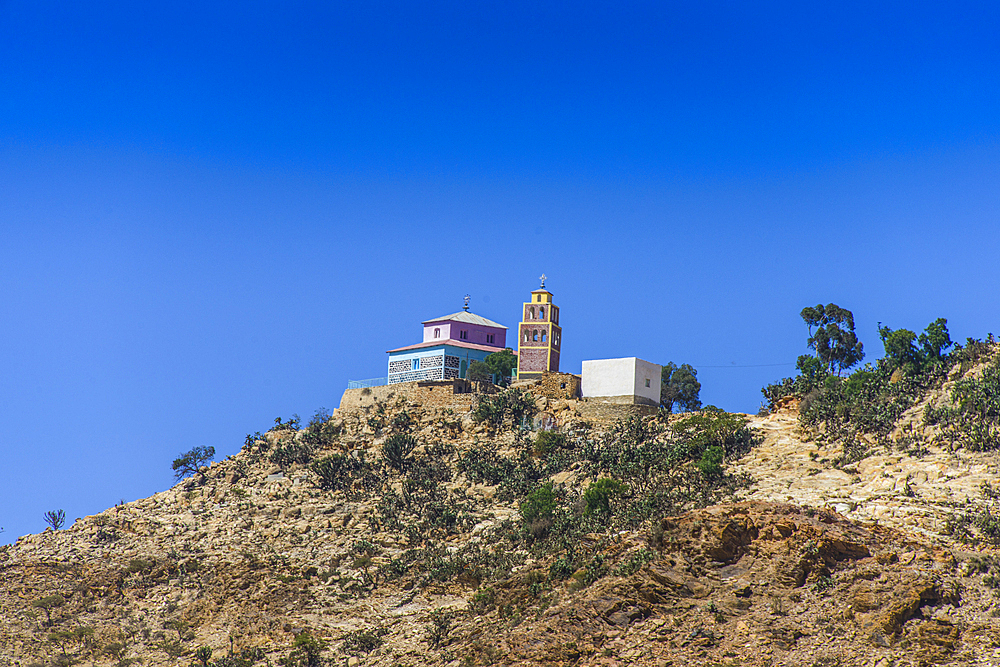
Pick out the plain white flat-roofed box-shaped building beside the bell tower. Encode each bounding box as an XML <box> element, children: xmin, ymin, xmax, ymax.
<box><xmin>580</xmin><ymin>357</ymin><xmax>662</xmax><ymax>405</ymax></box>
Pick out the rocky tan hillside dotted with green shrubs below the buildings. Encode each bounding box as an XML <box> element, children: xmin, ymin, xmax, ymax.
<box><xmin>0</xmin><ymin>352</ymin><xmax>1000</xmax><ymax>667</ymax></box>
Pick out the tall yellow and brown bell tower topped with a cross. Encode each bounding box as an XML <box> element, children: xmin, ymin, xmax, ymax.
<box><xmin>517</xmin><ymin>273</ymin><xmax>562</xmax><ymax>380</ymax></box>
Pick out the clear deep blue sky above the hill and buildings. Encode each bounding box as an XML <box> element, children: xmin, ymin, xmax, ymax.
<box><xmin>0</xmin><ymin>0</ymin><xmax>1000</xmax><ymax>541</ymax></box>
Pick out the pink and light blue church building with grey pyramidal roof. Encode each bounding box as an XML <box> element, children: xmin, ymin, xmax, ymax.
<box><xmin>388</xmin><ymin>297</ymin><xmax>507</xmax><ymax>384</ymax></box>
